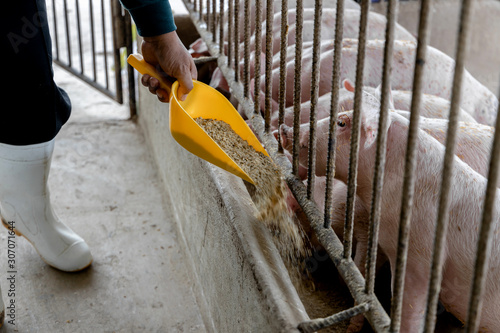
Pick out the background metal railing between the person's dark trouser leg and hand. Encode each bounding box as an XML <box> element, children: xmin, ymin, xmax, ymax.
<box><xmin>44</xmin><ymin>0</ymin><xmax>136</xmax><ymax>116</ymax></box>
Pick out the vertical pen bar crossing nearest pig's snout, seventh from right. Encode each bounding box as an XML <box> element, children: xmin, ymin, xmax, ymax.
<box><xmin>307</xmin><ymin>0</ymin><xmax>323</xmax><ymax>199</ymax></box>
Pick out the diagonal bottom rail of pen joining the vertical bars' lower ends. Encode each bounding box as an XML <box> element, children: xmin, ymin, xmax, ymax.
<box><xmin>179</xmin><ymin>4</ymin><xmax>390</xmax><ymax>332</ymax></box>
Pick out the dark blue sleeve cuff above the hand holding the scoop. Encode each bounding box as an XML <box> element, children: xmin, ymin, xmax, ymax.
<box><xmin>120</xmin><ymin>0</ymin><xmax>177</xmax><ymax>37</ymax></box>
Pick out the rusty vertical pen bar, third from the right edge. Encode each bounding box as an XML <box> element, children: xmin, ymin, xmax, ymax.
<box><xmin>390</xmin><ymin>0</ymin><xmax>431</xmax><ymax>332</ymax></box>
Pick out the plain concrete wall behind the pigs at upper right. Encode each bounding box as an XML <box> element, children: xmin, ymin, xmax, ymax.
<box><xmin>371</xmin><ymin>0</ymin><xmax>500</xmax><ymax>96</ymax></box>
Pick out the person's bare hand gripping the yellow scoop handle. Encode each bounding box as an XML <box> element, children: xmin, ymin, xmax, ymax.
<box><xmin>141</xmin><ymin>31</ymin><xmax>198</xmax><ymax>102</ymax></box>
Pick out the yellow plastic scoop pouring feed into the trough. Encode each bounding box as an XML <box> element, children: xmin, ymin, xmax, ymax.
<box><xmin>127</xmin><ymin>54</ymin><xmax>269</xmax><ymax>184</ymax></box>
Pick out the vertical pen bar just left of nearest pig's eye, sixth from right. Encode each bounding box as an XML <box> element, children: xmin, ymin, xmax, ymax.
<box><xmin>323</xmin><ymin>0</ymin><xmax>344</xmax><ymax>228</ymax></box>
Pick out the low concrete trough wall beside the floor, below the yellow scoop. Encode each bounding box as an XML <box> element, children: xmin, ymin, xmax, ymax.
<box><xmin>138</xmin><ymin>76</ymin><xmax>308</xmax><ymax>332</ymax></box>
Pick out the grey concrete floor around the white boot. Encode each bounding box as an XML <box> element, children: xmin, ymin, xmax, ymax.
<box><xmin>0</xmin><ymin>68</ymin><xmax>205</xmax><ymax>333</ymax></box>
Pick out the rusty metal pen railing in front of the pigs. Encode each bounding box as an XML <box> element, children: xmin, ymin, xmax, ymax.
<box><xmin>180</xmin><ymin>0</ymin><xmax>500</xmax><ymax>332</ymax></box>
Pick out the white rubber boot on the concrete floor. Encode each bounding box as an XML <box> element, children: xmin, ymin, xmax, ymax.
<box><xmin>0</xmin><ymin>140</ymin><xmax>92</xmax><ymax>272</ymax></box>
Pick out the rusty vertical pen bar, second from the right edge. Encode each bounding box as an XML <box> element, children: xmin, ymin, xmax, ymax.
<box><xmin>424</xmin><ymin>0</ymin><xmax>472</xmax><ymax>332</ymax></box>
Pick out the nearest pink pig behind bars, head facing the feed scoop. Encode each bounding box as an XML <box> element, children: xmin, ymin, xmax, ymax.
<box><xmin>328</xmin><ymin>107</ymin><xmax>500</xmax><ymax>332</ymax></box>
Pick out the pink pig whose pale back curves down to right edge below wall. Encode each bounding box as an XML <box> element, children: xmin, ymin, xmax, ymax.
<box><xmin>261</xmin><ymin>39</ymin><xmax>498</xmax><ymax>124</ymax></box>
